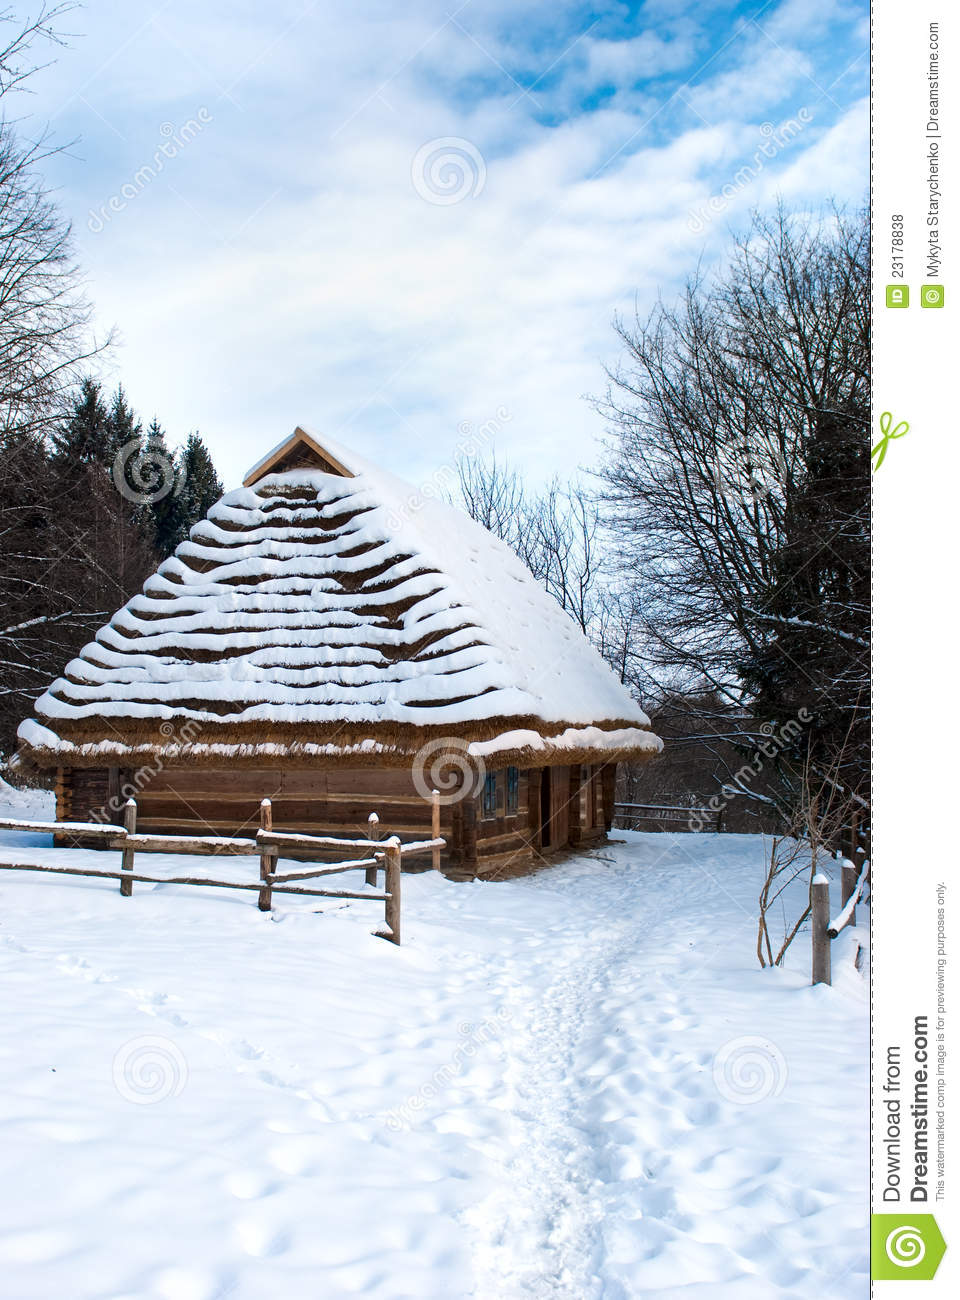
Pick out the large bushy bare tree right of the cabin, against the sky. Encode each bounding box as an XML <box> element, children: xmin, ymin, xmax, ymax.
<box><xmin>598</xmin><ymin>201</ymin><xmax>870</xmax><ymax>793</ymax></box>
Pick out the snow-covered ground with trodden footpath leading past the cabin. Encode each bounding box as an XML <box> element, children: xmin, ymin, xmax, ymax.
<box><xmin>0</xmin><ymin>796</ymin><xmax>869</xmax><ymax>1300</ymax></box>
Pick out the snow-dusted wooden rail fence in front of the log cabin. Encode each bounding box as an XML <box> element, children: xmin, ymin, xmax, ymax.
<box><xmin>0</xmin><ymin>790</ymin><xmax>446</xmax><ymax>944</ymax></box>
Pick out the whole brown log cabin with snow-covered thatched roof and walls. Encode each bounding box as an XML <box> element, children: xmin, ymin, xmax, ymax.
<box><xmin>20</xmin><ymin>429</ymin><xmax>661</xmax><ymax>879</ymax></box>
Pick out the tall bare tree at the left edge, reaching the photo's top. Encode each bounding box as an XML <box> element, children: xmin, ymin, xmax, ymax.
<box><xmin>0</xmin><ymin>3</ymin><xmax>130</xmax><ymax>751</ymax></box>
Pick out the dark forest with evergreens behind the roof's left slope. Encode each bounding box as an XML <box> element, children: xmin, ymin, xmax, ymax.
<box><xmin>0</xmin><ymin>378</ymin><xmax>224</xmax><ymax>753</ymax></box>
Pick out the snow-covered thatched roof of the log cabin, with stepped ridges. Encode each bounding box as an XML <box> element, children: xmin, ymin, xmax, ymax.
<box><xmin>20</xmin><ymin>429</ymin><xmax>660</xmax><ymax>766</ymax></box>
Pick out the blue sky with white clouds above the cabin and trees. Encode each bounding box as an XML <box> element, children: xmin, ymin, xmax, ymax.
<box><xmin>20</xmin><ymin>0</ymin><xmax>869</xmax><ymax>485</ymax></box>
